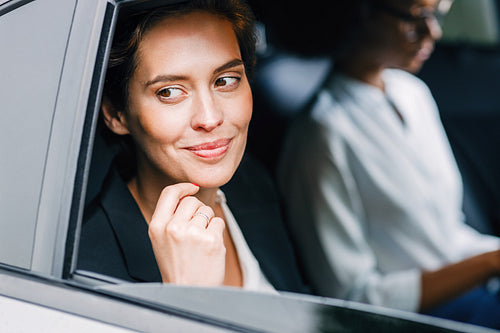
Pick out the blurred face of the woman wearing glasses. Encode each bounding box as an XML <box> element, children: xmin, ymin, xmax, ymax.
<box><xmin>364</xmin><ymin>0</ymin><xmax>442</xmax><ymax>72</ymax></box>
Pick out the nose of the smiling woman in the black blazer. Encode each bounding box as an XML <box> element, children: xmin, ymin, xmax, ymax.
<box><xmin>191</xmin><ymin>93</ymin><xmax>224</xmax><ymax>132</ymax></box>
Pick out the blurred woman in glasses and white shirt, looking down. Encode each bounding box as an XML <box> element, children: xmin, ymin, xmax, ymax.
<box><xmin>279</xmin><ymin>0</ymin><xmax>500</xmax><ymax>328</ymax></box>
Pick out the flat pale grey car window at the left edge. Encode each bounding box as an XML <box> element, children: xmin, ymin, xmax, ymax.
<box><xmin>0</xmin><ymin>0</ymin><xmax>75</xmax><ymax>269</ymax></box>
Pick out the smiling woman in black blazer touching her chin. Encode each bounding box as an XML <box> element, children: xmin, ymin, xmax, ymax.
<box><xmin>78</xmin><ymin>0</ymin><xmax>302</xmax><ymax>291</ymax></box>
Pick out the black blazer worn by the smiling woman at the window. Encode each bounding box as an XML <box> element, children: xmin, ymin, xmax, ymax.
<box><xmin>77</xmin><ymin>156</ymin><xmax>308</xmax><ymax>292</ymax></box>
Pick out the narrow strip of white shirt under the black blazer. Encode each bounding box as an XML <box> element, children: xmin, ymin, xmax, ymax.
<box><xmin>216</xmin><ymin>190</ymin><xmax>276</xmax><ymax>292</ymax></box>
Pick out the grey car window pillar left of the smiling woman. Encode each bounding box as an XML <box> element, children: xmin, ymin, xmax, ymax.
<box><xmin>25</xmin><ymin>0</ymin><xmax>114</xmax><ymax>278</ymax></box>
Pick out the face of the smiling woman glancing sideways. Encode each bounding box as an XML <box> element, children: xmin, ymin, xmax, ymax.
<box><xmin>119</xmin><ymin>12</ymin><xmax>252</xmax><ymax>187</ymax></box>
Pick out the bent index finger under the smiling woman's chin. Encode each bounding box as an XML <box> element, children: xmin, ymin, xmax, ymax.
<box><xmin>151</xmin><ymin>183</ymin><xmax>200</xmax><ymax>226</ymax></box>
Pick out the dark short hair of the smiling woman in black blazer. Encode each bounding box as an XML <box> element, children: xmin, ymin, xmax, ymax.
<box><xmin>104</xmin><ymin>0</ymin><xmax>256</xmax><ymax>111</ymax></box>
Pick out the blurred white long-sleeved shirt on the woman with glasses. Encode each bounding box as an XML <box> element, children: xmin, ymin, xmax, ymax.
<box><xmin>279</xmin><ymin>70</ymin><xmax>500</xmax><ymax>311</ymax></box>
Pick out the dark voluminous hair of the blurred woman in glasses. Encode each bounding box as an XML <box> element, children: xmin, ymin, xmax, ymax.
<box><xmin>252</xmin><ymin>0</ymin><xmax>380</xmax><ymax>57</ymax></box>
